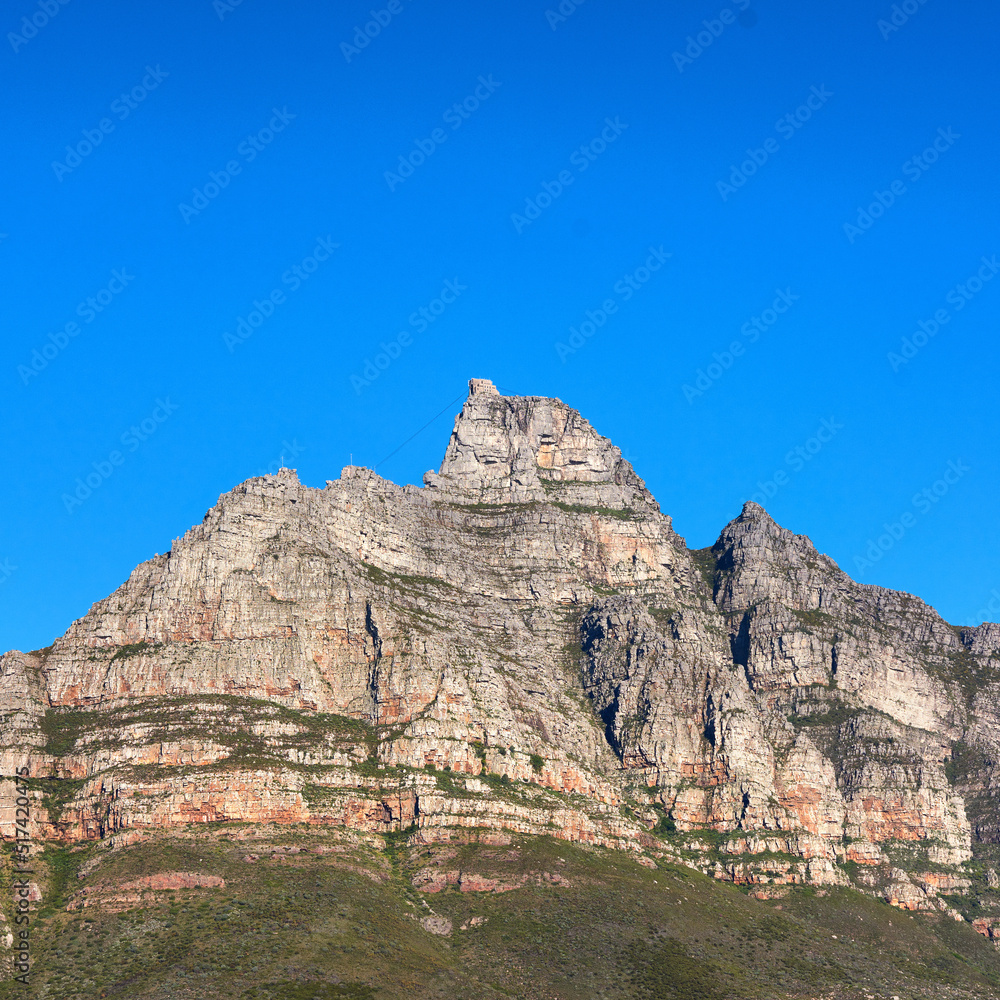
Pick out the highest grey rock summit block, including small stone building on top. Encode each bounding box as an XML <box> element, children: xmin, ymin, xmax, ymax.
<box><xmin>424</xmin><ymin>379</ymin><xmax>658</xmax><ymax>510</ymax></box>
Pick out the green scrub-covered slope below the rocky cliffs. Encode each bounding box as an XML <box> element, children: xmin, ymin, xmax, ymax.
<box><xmin>7</xmin><ymin>824</ymin><xmax>1000</xmax><ymax>1000</ymax></box>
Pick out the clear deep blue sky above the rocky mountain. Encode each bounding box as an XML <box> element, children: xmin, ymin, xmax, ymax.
<box><xmin>0</xmin><ymin>0</ymin><xmax>1000</xmax><ymax>649</ymax></box>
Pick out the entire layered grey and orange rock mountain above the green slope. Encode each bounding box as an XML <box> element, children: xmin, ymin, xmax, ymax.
<box><xmin>0</xmin><ymin>380</ymin><xmax>1000</xmax><ymax>910</ymax></box>
